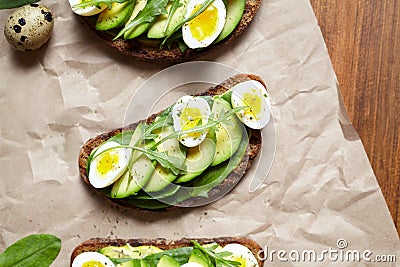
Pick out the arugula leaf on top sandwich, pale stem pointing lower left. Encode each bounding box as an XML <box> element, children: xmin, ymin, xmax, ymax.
<box><xmin>114</xmin><ymin>0</ymin><xmax>169</xmax><ymax>40</ymax></box>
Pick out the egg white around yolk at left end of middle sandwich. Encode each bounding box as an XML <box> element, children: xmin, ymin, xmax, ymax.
<box><xmin>89</xmin><ymin>141</ymin><xmax>131</xmax><ymax>188</ymax></box>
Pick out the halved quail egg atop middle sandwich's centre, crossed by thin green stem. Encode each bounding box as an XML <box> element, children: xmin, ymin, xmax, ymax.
<box><xmin>172</xmin><ymin>97</ymin><xmax>211</xmax><ymax>147</ymax></box>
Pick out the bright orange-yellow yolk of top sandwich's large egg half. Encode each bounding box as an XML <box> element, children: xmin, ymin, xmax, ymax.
<box><xmin>189</xmin><ymin>4</ymin><xmax>218</xmax><ymax>41</ymax></box>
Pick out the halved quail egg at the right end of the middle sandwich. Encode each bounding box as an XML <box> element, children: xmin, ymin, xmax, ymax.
<box><xmin>231</xmin><ymin>80</ymin><xmax>271</xmax><ymax>129</ymax></box>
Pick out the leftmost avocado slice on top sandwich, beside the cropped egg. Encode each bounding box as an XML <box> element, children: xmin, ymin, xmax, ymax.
<box><xmin>96</xmin><ymin>0</ymin><xmax>135</xmax><ymax>31</ymax></box>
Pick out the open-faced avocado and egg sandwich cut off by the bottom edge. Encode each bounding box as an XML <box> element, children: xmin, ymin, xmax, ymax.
<box><xmin>70</xmin><ymin>237</ymin><xmax>263</xmax><ymax>267</ymax></box>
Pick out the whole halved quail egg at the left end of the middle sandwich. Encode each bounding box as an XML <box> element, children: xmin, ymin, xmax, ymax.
<box><xmin>89</xmin><ymin>141</ymin><xmax>132</xmax><ymax>188</ymax></box>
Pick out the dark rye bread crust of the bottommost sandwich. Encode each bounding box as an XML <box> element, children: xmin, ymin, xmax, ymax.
<box><xmin>70</xmin><ymin>237</ymin><xmax>264</xmax><ymax>267</ymax></box>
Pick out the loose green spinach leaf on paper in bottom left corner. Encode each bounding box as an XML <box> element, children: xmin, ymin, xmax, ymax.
<box><xmin>0</xmin><ymin>234</ymin><xmax>61</xmax><ymax>267</ymax></box>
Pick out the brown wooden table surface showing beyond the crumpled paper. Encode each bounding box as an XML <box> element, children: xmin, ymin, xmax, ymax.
<box><xmin>310</xmin><ymin>0</ymin><xmax>400</xmax><ymax>233</ymax></box>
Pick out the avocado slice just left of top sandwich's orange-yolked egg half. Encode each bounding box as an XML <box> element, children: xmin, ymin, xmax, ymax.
<box><xmin>147</xmin><ymin>0</ymin><xmax>189</xmax><ymax>39</ymax></box>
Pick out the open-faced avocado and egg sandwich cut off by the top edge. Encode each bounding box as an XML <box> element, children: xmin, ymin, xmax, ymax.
<box><xmin>69</xmin><ymin>0</ymin><xmax>261</xmax><ymax>62</ymax></box>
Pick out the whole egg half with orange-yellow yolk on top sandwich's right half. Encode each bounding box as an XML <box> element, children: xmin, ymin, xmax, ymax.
<box><xmin>182</xmin><ymin>0</ymin><xmax>226</xmax><ymax>49</ymax></box>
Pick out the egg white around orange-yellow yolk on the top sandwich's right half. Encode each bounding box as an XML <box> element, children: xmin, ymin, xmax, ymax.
<box><xmin>182</xmin><ymin>0</ymin><xmax>226</xmax><ymax>49</ymax></box>
